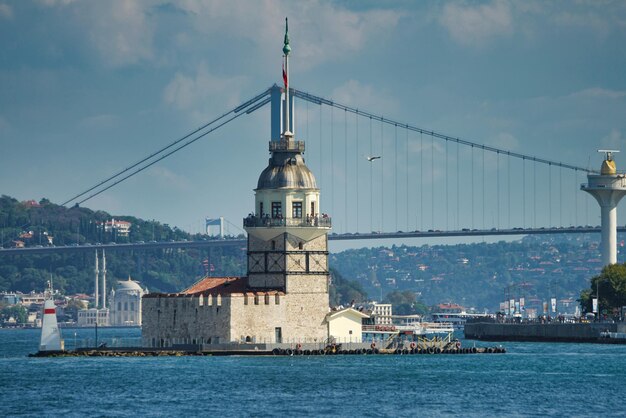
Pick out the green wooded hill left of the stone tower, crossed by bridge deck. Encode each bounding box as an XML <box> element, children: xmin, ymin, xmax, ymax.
<box><xmin>0</xmin><ymin>196</ymin><xmax>244</xmax><ymax>294</ymax></box>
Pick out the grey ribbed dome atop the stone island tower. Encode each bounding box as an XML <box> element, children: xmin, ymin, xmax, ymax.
<box><xmin>257</xmin><ymin>153</ymin><xmax>317</xmax><ymax>190</ymax></box>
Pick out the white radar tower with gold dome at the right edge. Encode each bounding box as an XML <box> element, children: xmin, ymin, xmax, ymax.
<box><xmin>580</xmin><ymin>150</ymin><xmax>626</xmax><ymax>266</ymax></box>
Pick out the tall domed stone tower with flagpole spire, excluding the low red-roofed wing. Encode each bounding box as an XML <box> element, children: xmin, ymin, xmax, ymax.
<box><xmin>243</xmin><ymin>19</ymin><xmax>331</xmax><ymax>341</ymax></box>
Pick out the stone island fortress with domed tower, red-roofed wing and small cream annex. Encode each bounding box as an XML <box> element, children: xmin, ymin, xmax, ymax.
<box><xmin>142</xmin><ymin>19</ymin><xmax>365</xmax><ymax>347</ymax></box>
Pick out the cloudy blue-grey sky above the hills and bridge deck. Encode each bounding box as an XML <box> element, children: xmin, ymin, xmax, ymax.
<box><xmin>0</xmin><ymin>0</ymin><xmax>626</xmax><ymax>242</ymax></box>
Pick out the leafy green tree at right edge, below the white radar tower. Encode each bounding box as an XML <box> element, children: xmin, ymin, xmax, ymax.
<box><xmin>579</xmin><ymin>263</ymin><xmax>626</xmax><ymax>313</ymax></box>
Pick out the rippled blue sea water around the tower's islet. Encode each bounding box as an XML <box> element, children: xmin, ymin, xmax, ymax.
<box><xmin>0</xmin><ymin>328</ymin><xmax>626</xmax><ymax>417</ymax></box>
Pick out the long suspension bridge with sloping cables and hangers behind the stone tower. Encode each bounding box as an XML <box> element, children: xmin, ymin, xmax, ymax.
<box><xmin>0</xmin><ymin>78</ymin><xmax>616</xmax><ymax>252</ymax></box>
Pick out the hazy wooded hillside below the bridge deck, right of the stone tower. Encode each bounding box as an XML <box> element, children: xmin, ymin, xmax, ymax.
<box><xmin>330</xmin><ymin>234</ymin><xmax>604</xmax><ymax>312</ymax></box>
